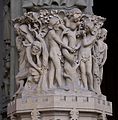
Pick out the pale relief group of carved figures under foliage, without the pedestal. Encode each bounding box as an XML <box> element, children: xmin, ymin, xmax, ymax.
<box><xmin>13</xmin><ymin>8</ymin><xmax>107</xmax><ymax>95</ymax></box>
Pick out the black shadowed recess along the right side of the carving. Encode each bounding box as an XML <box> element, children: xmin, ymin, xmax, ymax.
<box><xmin>93</xmin><ymin>0</ymin><xmax>118</xmax><ymax>120</ymax></box>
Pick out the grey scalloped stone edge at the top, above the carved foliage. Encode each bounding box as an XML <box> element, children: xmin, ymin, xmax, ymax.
<box><xmin>23</xmin><ymin>0</ymin><xmax>93</xmax><ymax>8</ymax></box>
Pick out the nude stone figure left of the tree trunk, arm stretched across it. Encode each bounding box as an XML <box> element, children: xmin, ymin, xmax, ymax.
<box><xmin>47</xmin><ymin>17</ymin><xmax>73</xmax><ymax>88</ymax></box>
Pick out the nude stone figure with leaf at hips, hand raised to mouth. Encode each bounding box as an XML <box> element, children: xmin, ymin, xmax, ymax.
<box><xmin>79</xmin><ymin>21</ymin><xmax>97</xmax><ymax>91</ymax></box>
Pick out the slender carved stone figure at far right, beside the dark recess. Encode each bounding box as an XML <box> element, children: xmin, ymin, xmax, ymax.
<box><xmin>92</xmin><ymin>28</ymin><xmax>108</xmax><ymax>94</ymax></box>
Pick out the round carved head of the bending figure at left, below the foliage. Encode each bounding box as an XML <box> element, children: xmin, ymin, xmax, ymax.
<box><xmin>31</xmin><ymin>41</ymin><xmax>41</xmax><ymax>55</ymax></box>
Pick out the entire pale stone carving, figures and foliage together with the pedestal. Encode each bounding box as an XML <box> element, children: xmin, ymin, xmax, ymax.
<box><xmin>8</xmin><ymin>0</ymin><xmax>112</xmax><ymax>120</ymax></box>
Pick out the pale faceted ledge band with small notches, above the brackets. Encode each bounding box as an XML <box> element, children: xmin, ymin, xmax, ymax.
<box><xmin>8</xmin><ymin>94</ymin><xmax>112</xmax><ymax>116</ymax></box>
